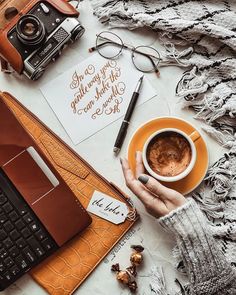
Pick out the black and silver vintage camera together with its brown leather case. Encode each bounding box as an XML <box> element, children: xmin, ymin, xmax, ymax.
<box><xmin>0</xmin><ymin>0</ymin><xmax>85</xmax><ymax>80</ymax></box>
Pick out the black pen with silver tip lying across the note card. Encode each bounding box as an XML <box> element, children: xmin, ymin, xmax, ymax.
<box><xmin>113</xmin><ymin>76</ymin><xmax>143</xmax><ymax>155</ymax></box>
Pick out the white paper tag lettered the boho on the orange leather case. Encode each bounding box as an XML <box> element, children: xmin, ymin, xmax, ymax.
<box><xmin>87</xmin><ymin>191</ymin><xmax>129</xmax><ymax>224</ymax></box>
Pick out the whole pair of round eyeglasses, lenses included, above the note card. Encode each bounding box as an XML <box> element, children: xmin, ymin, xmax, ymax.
<box><xmin>89</xmin><ymin>31</ymin><xmax>161</xmax><ymax>77</ymax></box>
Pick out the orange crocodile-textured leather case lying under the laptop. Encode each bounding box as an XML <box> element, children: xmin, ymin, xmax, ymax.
<box><xmin>0</xmin><ymin>93</ymin><xmax>134</xmax><ymax>295</ymax></box>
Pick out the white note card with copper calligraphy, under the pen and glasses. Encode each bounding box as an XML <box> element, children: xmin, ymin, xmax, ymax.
<box><xmin>40</xmin><ymin>53</ymin><xmax>156</xmax><ymax>144</ymax></box>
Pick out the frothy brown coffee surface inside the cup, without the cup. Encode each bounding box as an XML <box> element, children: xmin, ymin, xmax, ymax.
<box><xmin>147</xmin><ymin>131</ymin><xmax>192</xmax><ymax>177</ymax></box>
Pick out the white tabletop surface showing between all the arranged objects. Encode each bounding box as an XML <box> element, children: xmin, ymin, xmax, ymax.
<box><xmin>0</xmin><ymin>0</ymin><xmax>224</xmax><ymax>295</ymax></box>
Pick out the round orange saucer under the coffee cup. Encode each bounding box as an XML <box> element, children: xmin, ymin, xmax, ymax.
<box><xmin>128</xmin><ymin>117</ymin><xmax>209</xmax><ymax>195</ymax></box>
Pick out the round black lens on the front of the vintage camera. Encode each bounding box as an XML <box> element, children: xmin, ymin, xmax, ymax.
<box><xmin>16</xmin><ymin>14</ymin><xmax>46</xmax><ymax>46</ymax></box>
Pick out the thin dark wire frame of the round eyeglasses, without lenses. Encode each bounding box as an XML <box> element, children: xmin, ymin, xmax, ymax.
<box><xmin>89</xmin><ymin>31</ymin><xmax>161</xmax><ymax>77</ymax></box>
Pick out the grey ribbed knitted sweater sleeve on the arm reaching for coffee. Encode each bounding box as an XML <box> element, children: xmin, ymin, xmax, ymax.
<box><xmin>159</xmin><ymin>198</ymin><xmax>236</xmax><ymax>295</ymax></box>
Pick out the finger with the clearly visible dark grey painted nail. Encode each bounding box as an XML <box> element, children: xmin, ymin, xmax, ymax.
<box><xmin>138</xmin><ymin>174</ymin><xmax>170</xmax><ymax>199</ymax></box>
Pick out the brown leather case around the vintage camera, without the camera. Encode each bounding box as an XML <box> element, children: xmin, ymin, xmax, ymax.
<box><xmin>0</xmin><ymin>0</ymin><xmax>79</xmax><ymax>74</ymax></box>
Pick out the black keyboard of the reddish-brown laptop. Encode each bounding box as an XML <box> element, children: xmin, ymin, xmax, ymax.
<box><xmin>0</xmin><ymin>169</ymin><xmax>58</xmax><ymax>291</ymax></box>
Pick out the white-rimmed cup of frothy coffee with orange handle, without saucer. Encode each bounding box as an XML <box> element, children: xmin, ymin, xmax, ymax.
<box><xmin>143</xmin><ymin>128</ymin><xmax>200</xmax><ymax>182</ymax></box>
